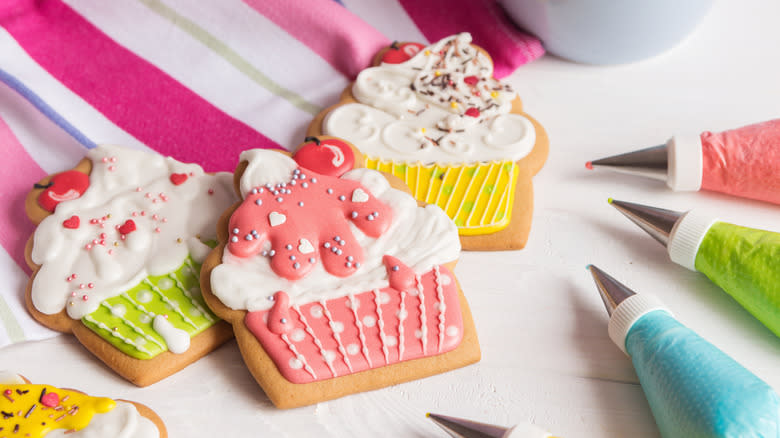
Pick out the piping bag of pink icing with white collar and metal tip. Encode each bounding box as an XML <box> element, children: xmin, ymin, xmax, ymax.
<box><xmin>585</xmin><ymin>119</ymin><xmax>780</xmax><ymax>204</ymax></box>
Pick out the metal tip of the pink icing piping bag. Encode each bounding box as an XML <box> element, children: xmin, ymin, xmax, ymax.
<box><xmin>585</xmin><ymin>144</ymin><xmax>669</xmax><ymax>181</ymax></box>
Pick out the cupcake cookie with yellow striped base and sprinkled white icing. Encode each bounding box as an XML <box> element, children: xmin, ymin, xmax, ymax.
<box><xmin>309</xmin><ymin>33</ymin><xmax>548</xmax><ymax>250</ymax></box>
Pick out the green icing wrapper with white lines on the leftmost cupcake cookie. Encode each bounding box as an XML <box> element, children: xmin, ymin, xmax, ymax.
<box><xmin>81</xmin><ymin>257</ymin><xmax>219</xmax><ymax>359</ymax></box>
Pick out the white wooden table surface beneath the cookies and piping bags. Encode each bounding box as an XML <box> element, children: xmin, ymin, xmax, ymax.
<box><xmin>6</xmin><ymin>0</ymin><xmax>780</xmax><ymax>437</ymax></box>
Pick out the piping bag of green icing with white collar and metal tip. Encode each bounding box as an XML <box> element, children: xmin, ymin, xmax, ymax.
<box><xmin>609</xmin><ymin>199</ymin><xmax>780</xmax><ymax>336</ymax></box>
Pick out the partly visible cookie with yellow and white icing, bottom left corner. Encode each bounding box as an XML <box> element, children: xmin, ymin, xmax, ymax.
<box><xmin>0</xmin><ymin>371</ymin><xmax>168</xmax><ymax>438</ymax></box>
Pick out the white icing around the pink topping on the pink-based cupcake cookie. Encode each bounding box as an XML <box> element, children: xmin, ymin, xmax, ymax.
<box><xmin>211</xmin><ymin>151</ymin><xmax>460</xmax><ymax>311</ymax></box>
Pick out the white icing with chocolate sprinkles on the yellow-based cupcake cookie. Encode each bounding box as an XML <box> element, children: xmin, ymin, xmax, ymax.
<box><xmin>323</xmin><ymin>33</ymin><xmax>536</xmax><ymax>164</ymax></box>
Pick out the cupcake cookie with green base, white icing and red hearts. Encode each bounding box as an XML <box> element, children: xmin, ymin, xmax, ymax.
<box><xmin>26</xmin><ymin>146</ymin><xmax>236</xmax><ymax>386</ymax></box>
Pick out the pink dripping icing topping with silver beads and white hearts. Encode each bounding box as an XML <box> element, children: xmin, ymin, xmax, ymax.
<box><xmin>227</xmin><ymin>167</ymin><xmax>392</xmax><ymax>280</ymax></box>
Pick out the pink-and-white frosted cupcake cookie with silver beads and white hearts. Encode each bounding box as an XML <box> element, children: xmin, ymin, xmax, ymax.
<box><xmin>201</xmin><ymin>137</ymin><xmax>480</xmax><ymax>408</ymax></box>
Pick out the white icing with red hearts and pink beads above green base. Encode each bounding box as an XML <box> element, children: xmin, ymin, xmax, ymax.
<box><xmin>32</xmin><ymin>146</ymin><xmax>235</xmax><ymax>319</ymax></box>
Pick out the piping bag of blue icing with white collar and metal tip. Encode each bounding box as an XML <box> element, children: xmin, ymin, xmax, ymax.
<box><xmin>588</xmin><ymin>265</ymin><xmax>780</xmax><ymax>438</ymax></box>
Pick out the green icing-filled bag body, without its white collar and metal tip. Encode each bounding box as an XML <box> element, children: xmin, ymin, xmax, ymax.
<box><xmin>695</xmin><ymin>222</ymin><xmax>780</xmax><ymax>336</ymax></box>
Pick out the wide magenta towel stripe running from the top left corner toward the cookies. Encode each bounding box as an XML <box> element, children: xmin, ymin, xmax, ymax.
<box><xmin>0</xmin><ymin>0</ymin><xmax>279</xmax><ymax>171</ymax></box>
